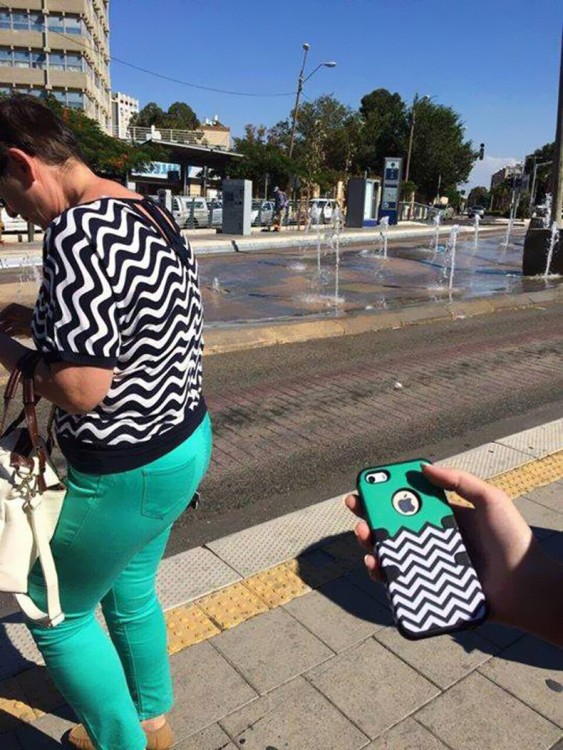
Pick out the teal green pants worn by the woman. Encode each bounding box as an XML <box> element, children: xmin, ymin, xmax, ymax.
<box><xmin>28</xmin><ymin>416</ymin><xmax>211</xmax><ymax>750</ymax></box>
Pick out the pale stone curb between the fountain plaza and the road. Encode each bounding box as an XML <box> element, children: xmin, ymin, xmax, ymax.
<box><xmin>204</xmin><ymin>286</ymin><xmax>563</xmax><ymax>355</ymax></box>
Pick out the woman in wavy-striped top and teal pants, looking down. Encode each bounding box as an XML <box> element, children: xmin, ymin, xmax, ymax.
<box><xmin>0</xmin><ymin>96</ymin><xmax>211</xmax><ymax>750</ymax></box>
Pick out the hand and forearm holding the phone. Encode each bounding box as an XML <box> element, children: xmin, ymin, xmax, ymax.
<box><xmin>346</xmin><ymin>465</ymin><xmax>563</xmax><ymax>646</ymax></box>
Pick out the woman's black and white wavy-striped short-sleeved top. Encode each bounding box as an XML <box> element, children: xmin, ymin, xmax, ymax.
<box><xmin>32</xmin><ymin>198</ymin><xmax>205</xmax><ymax>474</ymax></box>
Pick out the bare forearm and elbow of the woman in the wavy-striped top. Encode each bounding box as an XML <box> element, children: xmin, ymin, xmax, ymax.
<box><xmin>0</xmin><ymin>333</ymin><xmax>113</xmax><ymax>414</ymax></box>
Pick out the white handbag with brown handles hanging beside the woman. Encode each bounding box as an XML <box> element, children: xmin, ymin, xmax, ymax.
<box><xmin>0</xmin><ymin>368</ymin><xmax>66</xmax><ymax>627</ymax></box>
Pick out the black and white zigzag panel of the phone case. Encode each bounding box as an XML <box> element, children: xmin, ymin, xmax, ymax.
<box><xmin>377</xmin><ymin>524</ymin><xmax>486</xmax><ymax>636</ymax></box>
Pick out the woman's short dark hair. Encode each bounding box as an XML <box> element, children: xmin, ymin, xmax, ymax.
<box><xmin>0</xmin><ymin>94</ymin><xmax>83</xmax><ymax>176</ymax></box>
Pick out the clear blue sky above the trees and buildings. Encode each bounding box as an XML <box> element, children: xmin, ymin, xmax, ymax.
<box><xmin>110</xmin><ymin>0</ymin><xmax>563</xmax><ymax>187</ymax></box>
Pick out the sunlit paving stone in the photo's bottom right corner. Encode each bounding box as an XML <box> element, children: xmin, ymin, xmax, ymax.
<box><xmin>414</xmin><ymin>672</ymin><xmax>560</xmax><ymax>750</ymax></box>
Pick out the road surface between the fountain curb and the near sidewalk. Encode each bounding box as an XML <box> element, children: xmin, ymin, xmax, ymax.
<box><xmin>167</xmin><ymin>304</ymin><xmax>563</xmax><ymax>554</ymax></box>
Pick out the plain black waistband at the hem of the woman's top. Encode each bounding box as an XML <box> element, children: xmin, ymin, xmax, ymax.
<box><xmin>57</xmin><ymin>397</ymin><xmax>207</xmax><ymax>474</ymax></box>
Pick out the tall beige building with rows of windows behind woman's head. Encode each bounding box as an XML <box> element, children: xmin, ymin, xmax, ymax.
<box><xmin>0</xmin><ymin>0</ymin><xmax>111</xmax><ymax>133</ymax></box>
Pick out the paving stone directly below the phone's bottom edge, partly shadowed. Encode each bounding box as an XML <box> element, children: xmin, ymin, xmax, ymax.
<box><xmin>374</xmin><ymin>628</ymin><xmax>498</xmax><ymax>688</ymax></box>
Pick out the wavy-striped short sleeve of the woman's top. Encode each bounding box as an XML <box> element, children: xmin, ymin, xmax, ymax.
<box><xmin>32</xmin><ymin>210</ymin><xmax>120</xmax><ymax>368</ymax></box>
